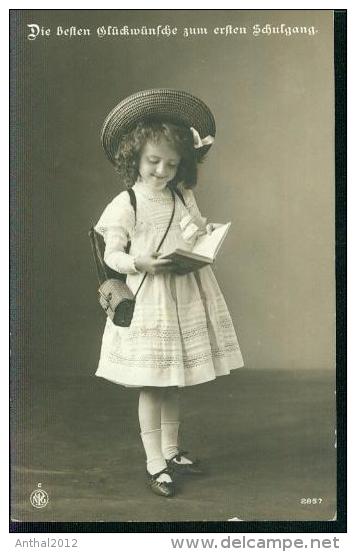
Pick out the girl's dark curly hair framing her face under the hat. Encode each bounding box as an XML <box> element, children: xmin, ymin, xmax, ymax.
<box><xmin>115</xmin><ymin>120</ymin><xmax>202</xmax><ymax>188</ymax></box>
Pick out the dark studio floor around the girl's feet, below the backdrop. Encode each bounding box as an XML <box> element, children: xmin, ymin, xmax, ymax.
<box><xmin>11</xmin><ymin>369</ymin><xmax>336</xmax><ymax>523</ymax></box>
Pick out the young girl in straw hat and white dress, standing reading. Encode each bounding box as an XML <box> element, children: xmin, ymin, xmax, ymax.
<box><xmin>96</xmin><ymin>89</ymin><xmax>243</xmax><ymax>497</ymax></box>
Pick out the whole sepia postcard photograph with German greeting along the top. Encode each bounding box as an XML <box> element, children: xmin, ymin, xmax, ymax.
<box><xmin>10</xmin><ymin>9</ymin><xmax>346</xmax><ymax>532</ymax></box>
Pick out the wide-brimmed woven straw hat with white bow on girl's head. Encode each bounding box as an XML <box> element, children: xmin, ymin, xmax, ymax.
<box><xmin>101</xmin><ymin>88</ymin><xmax>216</xmax><ymax>164</ymax></box>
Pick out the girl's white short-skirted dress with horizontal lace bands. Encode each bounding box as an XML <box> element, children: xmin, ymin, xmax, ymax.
<box><xmin>96</xmin><ymin>182</ymin><xmax>243</xmax><ymax>387</ymax></box>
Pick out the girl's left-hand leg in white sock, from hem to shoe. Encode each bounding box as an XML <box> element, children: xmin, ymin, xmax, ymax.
<box><xmin>138</xmin><ymin>387</ymin><xmax>167</xmax><ymax>477</ymax></box>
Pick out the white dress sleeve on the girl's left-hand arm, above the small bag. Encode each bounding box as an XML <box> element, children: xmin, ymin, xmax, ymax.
<box><xmin>95</xmin><ymin>192</ymin><xmax>138</xmax><ymax>274</ymax></box>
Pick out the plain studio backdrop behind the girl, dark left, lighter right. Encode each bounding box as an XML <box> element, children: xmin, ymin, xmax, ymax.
<box><xmin>11</xmin><ymin>10</ymin><xmax>335</xmax><ymax>520</ymax></box>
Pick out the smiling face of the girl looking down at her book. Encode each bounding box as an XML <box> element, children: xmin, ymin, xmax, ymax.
<box><xmin>139</xmin><ymin>137</ymin><xmax>181</xmax><ymax>190</ymax></box>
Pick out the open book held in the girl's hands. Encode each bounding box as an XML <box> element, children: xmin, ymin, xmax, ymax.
<box><xmin>160</xmin><ymin>222</ymin><xmax>231</xmax><ymax>274</ymax></box>
